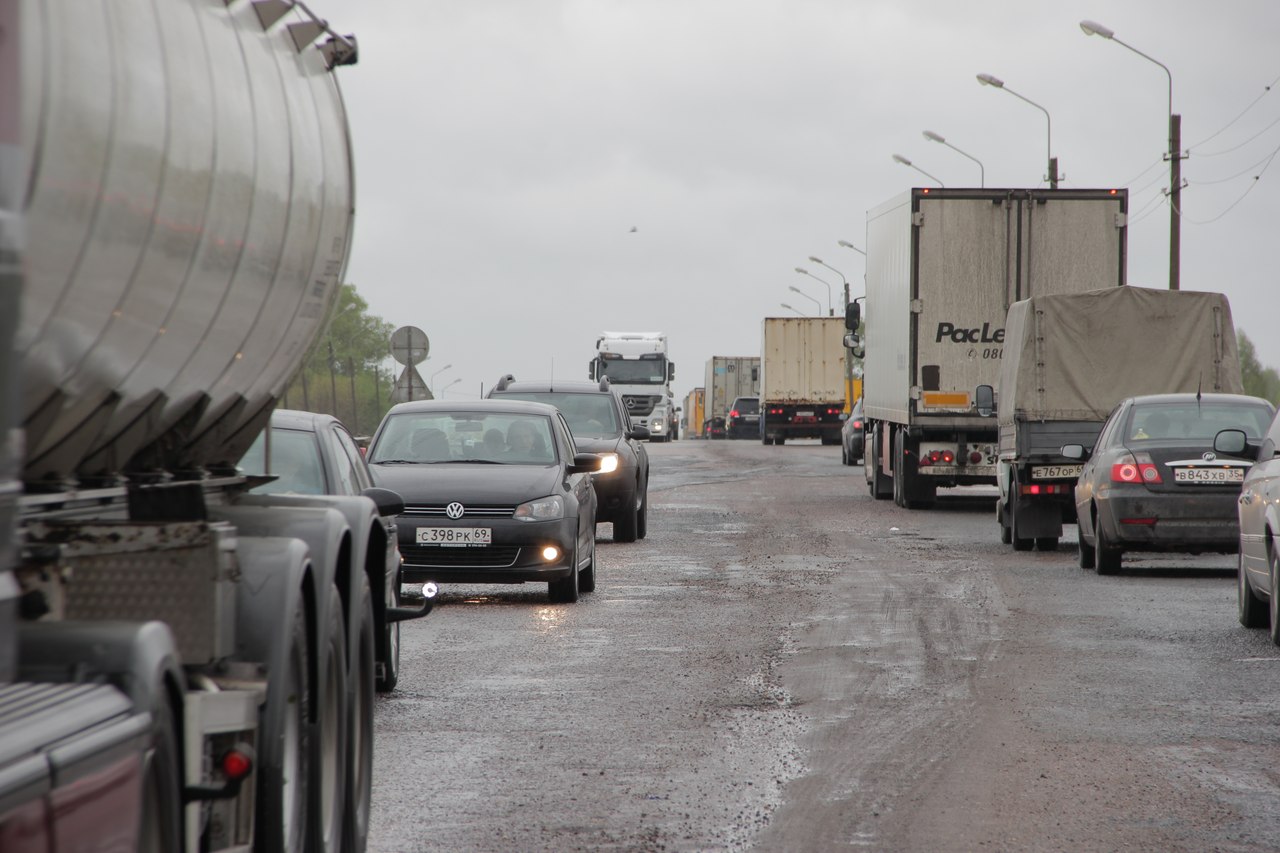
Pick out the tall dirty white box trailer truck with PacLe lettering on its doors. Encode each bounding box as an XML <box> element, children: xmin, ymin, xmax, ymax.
<box><xmin>845</xmin><ymin>188</ymin><xmax>1128</xmax><ymax>507</ymax></box>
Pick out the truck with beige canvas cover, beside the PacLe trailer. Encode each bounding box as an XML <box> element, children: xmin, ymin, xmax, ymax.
<box><xmin>975</xmin><ymin>287</ymin><xmax>1244</xmax><ymax>551</ymax></box>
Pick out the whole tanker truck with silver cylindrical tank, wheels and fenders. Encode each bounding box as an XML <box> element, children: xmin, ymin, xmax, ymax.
<box><xmin>0</xmin><ymin>0</ymin><xmax>430</xmax><ymax>853</ymax></box>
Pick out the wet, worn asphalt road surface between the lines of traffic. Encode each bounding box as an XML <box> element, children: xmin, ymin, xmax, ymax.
<box><xmin>369</xmin><ymin>441</ymin><xmax>1280</xmax><ymax>853</ymax></box>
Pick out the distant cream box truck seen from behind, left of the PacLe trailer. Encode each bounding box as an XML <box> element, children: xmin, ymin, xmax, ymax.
<box><xmin>759</xmin><ymin>316</ymin><xmax>846</xmax><ymax>444</ymax></box>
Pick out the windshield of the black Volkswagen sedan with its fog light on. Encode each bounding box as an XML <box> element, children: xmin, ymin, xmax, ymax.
<box><xmin>369</xmin><ymin>411</ymin><xmax>556</xmax><ymax>465</ymax></box>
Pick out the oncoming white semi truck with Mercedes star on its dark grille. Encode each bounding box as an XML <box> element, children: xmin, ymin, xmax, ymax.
<box><xmin>588</xmin><ymin>332</ymin><xmax>678</xmax><ymax>442</ymax></box>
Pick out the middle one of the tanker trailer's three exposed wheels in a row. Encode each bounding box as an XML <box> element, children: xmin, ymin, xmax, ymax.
<box><xmin>311</xmin><ymin>587</ymin><xmax>351</xmax><ymax>853</ymax></box>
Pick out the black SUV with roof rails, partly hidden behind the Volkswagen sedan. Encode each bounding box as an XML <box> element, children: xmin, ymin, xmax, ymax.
<box><xmin>486</xmin><ymin>374</ymin><xmax>649</xmax><ymax>542</ymax></box>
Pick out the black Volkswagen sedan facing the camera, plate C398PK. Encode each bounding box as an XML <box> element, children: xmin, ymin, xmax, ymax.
<box><xmin>367</xmin><ymin>400</ymin><xmax>603</xmax><ymax>602</ymax></box>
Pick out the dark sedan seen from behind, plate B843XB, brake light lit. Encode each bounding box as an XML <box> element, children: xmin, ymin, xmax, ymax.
<box><xmin>1062</xmin><ymin>393</ymin><xmax>1275</xmax><ymax>574</ymax></box>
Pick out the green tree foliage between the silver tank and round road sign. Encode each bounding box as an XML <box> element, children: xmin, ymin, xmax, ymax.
<box><xmin>280</xmin><ymin>284</ymin><xmax>396</xmax><ymax>435</ymax></box>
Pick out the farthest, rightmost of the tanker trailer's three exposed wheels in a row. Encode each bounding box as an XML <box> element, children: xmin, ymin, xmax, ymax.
<box><xmin>342</xmin><ymin>576</ymin><xmax>375</xmax><ymax>853</ymax></box>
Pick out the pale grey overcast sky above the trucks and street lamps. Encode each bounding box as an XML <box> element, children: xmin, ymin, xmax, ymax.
<box><xmin>337</xmin><ymin>0</ymin><xmax>1280</xmax><ymax>398</ymax></box>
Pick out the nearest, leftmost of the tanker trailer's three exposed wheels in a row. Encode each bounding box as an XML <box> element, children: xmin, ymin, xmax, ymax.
<box><xmin>253</xmin><ymin>596</ymin><xmax>311</xmax><ymax>853</ymax></box>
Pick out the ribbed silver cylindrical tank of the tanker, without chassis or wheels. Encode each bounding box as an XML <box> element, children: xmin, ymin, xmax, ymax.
<box><xmin>17</xmin><ymin>0</ymin><xmax>353</xmax><ymax>488</ymax></box>
